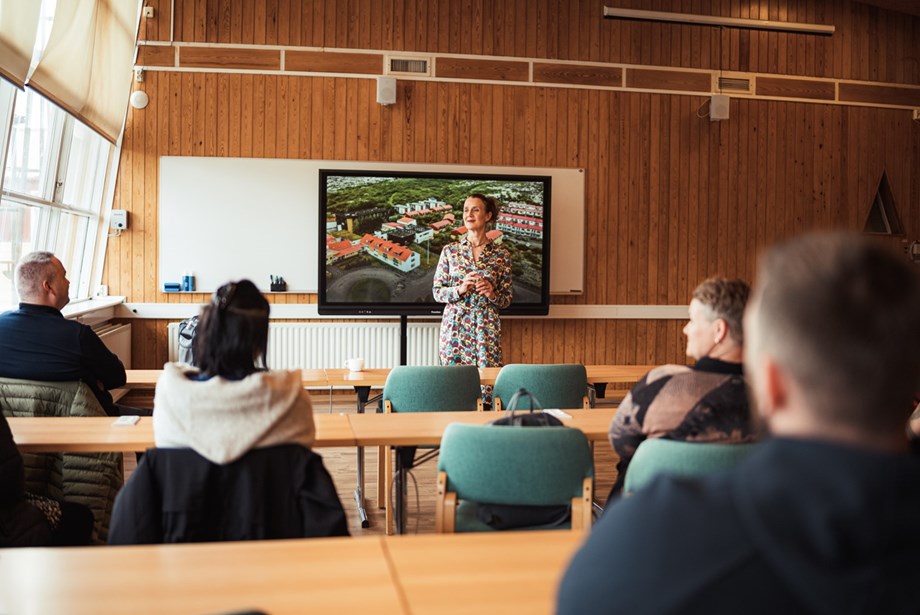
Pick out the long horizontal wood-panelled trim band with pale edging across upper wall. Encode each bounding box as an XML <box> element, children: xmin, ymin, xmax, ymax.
<box><xmin>135</xmin><ymin>41</ymin><xmax>920</xmax><ymax>109</ymax></box>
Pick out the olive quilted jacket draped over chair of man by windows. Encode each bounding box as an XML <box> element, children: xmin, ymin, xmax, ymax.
<box><xmin>0</xmin><ymin>378</ymin><xmax>124</xmax><ymax>544</ymax></box>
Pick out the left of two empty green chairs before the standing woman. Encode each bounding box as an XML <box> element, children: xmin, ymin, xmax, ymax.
<box><xmin>378</xmin><ymin>365</ymin><xmax>482</xmax><ymax>534</ymax></box>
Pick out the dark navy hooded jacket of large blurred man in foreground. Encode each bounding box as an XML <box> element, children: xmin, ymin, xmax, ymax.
<box><xmin>558</xmin><ymin>439</ymin><xmax>920</xmax><ymax>615</ymax></box>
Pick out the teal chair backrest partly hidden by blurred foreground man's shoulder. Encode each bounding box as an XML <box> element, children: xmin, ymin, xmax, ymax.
<box><xmin>623</xmin><ymin>438</ymin><xmax>757</xmax><ymax>493</ymax></box>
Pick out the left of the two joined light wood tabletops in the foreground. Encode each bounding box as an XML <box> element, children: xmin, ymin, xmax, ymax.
<box><xmin>0</xmin><ymin>536</ymin><xmax>405</xmax><ymax>615</ymax></box>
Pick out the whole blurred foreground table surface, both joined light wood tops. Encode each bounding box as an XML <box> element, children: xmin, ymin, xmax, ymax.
<box><xmin>0</xmin><ymin>531</ymin><xmax>584</xmax><ymax>615</ymax></box>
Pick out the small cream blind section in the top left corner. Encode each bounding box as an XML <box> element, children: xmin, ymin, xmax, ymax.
<box><xmin>0</xmin><ymin>0</ymin><xmax>42</xmax><ymax>87</ymax></box>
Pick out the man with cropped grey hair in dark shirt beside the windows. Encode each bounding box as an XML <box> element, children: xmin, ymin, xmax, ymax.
<box><xmin>0</xmin><ymin>252</ymin><xmax>125</xmax><ymax>416</ymax></box>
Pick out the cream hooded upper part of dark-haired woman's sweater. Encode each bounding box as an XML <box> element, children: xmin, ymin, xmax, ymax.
<box><xmin>153</xmin><ymin>363</ymin><xmax>316</xmax><ymax>464</ymax></box>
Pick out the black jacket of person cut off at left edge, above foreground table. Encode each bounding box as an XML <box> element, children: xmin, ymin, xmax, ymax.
<box><xmin>0</xmin><ymin>412</ymin><xmax>51</xmax><ymax>547</ymax></box>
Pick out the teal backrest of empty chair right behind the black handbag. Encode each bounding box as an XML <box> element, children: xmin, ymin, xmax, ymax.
<box><xmin>438</xmin><ymin>423</ymin><xmax>594</xmax><ymax>506</ymax></box>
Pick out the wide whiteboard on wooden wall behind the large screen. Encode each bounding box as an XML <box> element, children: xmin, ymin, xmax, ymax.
<box><xmin>158</xmin><ymin>156</ymin><xmax>585</xmax><ymax>295</ymax></box>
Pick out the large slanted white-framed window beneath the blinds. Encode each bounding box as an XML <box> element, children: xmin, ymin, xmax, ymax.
<box><xmin>0</xmin><ymin>79</ymin><xmax>112</xmax><ymax>310</ymax></box>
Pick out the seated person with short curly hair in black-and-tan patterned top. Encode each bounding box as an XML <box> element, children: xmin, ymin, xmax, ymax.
<box><xmin>608</xmin><ymin>278</ymin><xmax>754</xmax><ymax>501</ymax></box>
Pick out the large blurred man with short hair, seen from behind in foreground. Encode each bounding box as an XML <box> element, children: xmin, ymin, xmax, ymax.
<box><xmin>558</xmin><ymin>234</ymin><xmax>920</xmax><ymax>615</ymax></box>
